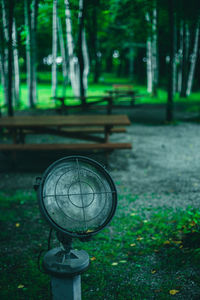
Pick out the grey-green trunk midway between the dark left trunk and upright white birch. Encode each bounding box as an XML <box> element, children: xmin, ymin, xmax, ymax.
<box><xmin>24</xmin><ymin>0</ymin><xmax>34</xmax><ymax>107</ymax></box>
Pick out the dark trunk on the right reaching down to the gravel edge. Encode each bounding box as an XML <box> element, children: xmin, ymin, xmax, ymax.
<box><xmin>166</xmin><ymin>0</ymin><xmax>175</xmax><ymax>122</ymax></box>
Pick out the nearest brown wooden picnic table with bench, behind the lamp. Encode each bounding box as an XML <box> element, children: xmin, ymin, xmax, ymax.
<box><xmin>0</xmin><ymin>115</ymin><xmax>131</xmax><ymax>151</ymax></box>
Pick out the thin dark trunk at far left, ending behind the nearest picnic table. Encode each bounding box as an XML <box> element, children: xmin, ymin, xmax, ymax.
<box><xmin>8</xmin><ymin>0</ymin><xmax>14</xmax><ymax>116</ymax></box>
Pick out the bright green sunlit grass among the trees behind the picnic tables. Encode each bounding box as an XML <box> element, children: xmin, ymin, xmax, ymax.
<box><xmin>0</xmin><ymin>72</ymin><xmax>200</xmax><ymax>110</ymax></box>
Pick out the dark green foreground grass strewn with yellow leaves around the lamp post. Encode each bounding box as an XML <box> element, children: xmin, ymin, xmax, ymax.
<box><xmin>0</xmin><ymin>191</ymin><xmax>200</xmax><ymax>300</ymax></box>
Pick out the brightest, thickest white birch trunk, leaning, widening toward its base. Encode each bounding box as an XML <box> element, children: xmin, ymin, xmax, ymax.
<box><xmin>65</xmin><ymin>0</ymin><xmax>80</xmax><ymax>97</ymax></box>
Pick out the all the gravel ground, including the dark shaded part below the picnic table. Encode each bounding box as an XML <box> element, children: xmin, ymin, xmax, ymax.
<box><xmin>0</xmin><ymin>107</ymin><xmax>200</xmax><ymax>213</ymax></box>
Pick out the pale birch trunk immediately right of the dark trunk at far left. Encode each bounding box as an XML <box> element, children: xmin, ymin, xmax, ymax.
<box><xmin>13</xmin><ymin>19</ymin><xmax>20</xmax><ymax>106</ymax></box>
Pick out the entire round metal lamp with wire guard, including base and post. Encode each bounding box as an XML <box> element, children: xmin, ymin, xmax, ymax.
<box><xmin>36</xmin><ymin>156</ymin><xmax>117</xmax><ymax>299</ymax></box>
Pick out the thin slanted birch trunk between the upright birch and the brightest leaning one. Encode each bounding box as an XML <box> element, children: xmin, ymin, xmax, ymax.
<box><xmin>57</xmin><ymin>17</ymin><xmax>68</xmax><ymax>97</ymax></box>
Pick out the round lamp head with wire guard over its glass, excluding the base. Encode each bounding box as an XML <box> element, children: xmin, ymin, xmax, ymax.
<box><xmin>38</xmin><ymin>156</ymin><xmax>117</xmax><ymax>237</ymax></box>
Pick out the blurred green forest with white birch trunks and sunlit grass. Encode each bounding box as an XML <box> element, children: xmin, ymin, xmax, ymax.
<box><xmin>0</xmin><ymin>0</ymin><xmax>200</xmax><ymax>120</ymax></box>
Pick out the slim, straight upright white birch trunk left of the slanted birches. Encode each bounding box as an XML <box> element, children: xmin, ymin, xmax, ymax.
<box><xmin>52</xmin><ymin>0</ymin><xmax>58</xmax><ymax>98</ymax></box>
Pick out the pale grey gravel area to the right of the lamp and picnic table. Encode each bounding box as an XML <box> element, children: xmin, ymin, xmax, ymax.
<box><xmin>110</xmin><ymin>123</ymin><xmax>200</xmax><ymax>214</ymax></box>
